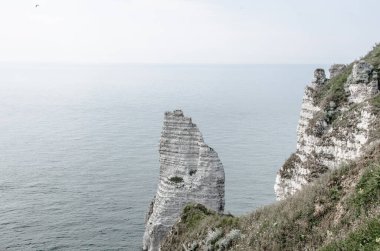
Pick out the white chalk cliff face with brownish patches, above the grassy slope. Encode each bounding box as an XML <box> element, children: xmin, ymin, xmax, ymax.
<box><xmin>274</xmin><ymin>61</ymin><xmax>379</xmax><ymax>200</ymax></box>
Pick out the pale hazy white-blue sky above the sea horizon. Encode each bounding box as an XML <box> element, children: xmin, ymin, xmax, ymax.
<box><xmin>0</xmin><ymin>0</ymin><xmax>380</xmax><ymax>63</ymax></box>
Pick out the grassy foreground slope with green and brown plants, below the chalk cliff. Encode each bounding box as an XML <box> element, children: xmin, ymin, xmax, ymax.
<box><xmin>164</xmin><ymin>144</ymin><xmax>380</xmax><ymax>251</ymax></box>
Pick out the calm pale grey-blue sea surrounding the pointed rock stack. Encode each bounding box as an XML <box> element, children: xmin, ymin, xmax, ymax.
<box><xmin>0</xmin><ymin>65</ymin><xmax>324</xmax><ymax>250</ymax></box>
